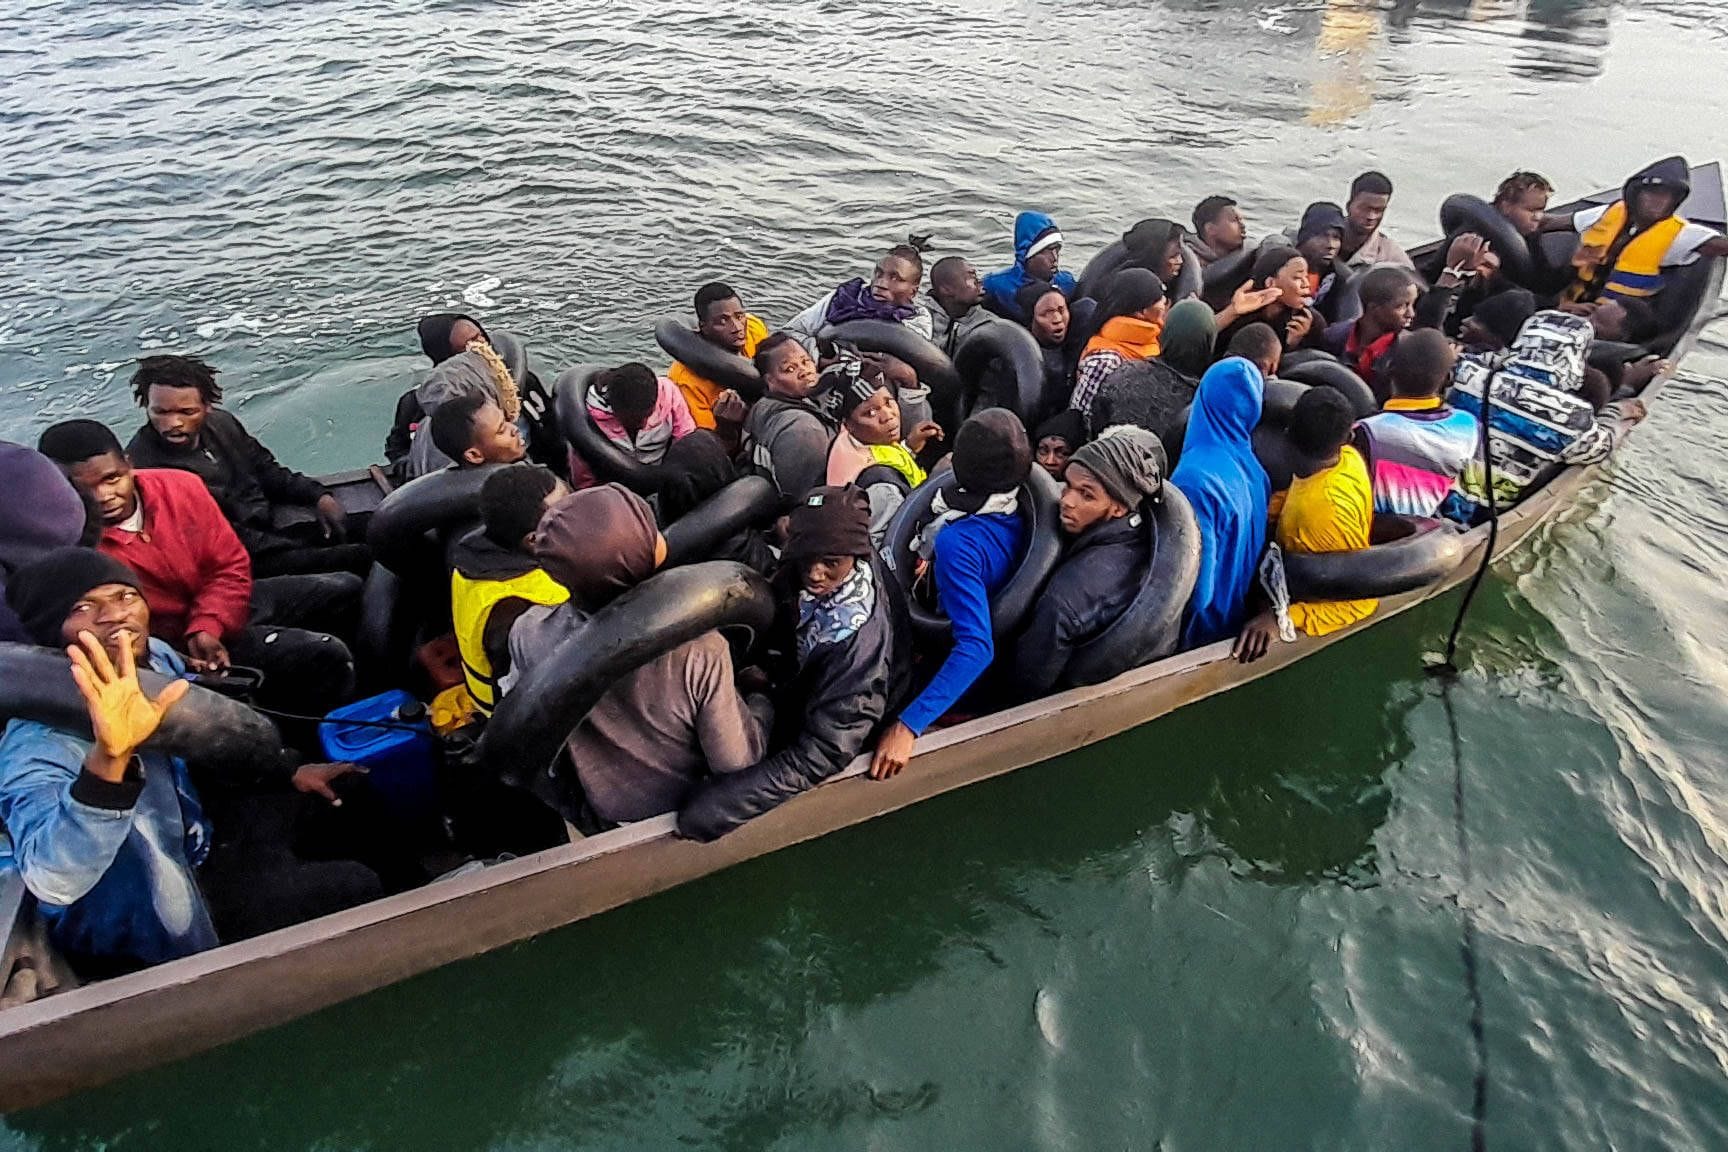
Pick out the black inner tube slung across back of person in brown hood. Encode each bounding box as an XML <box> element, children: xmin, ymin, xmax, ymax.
<box><xmin>470</xmin><ymin>560</ymin><xmax>774</xmax><ymax>786</ymax></box>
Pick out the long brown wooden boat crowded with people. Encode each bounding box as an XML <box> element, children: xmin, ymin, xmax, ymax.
<box><xmin>0</xmin><ymin>164</ymin><xmax>1728</xmax><ymax>1111</ymax></box>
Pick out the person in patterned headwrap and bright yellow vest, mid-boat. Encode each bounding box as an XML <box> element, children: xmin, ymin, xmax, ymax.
<box><xmin>821</xmin><ymin>359</ymin><xmax>942</xmax><ymax>544</ymax></box>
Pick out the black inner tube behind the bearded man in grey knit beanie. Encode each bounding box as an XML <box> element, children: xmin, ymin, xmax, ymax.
<box><xmin>1064</xmin><ymin>484</ymin><xmax>1199</xmax><ymax>686</ymax></box>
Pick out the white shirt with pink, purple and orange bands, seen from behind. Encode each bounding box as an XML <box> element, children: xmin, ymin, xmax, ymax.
<box><xmin>1356</xmin><ymin>396</ymin><xmax>1481</xmax><ymax>516</ymax></box>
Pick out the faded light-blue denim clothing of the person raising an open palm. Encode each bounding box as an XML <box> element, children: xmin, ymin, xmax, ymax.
<box><xmin>0</xmin><ymin>639</ymin><xmax>216</xmax><ymax>964</ymax></box>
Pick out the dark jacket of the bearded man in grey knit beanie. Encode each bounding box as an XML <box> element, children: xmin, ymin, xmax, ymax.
<box><xmin>1013</xmin><ymin>511</ymin><xmax>1147</xmax><ymax>699</ymax></box>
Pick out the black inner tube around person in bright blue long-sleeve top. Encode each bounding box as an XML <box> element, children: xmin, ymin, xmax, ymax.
<box><xmin>881</xmin><ymin>466</ymin><xmax>1063</xmax><ymax>641</ymax></box>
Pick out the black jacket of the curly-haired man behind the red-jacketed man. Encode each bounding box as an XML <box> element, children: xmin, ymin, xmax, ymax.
<box><xmin>126</xmin><ymin>408</ymin><xmax>325</xmax><ymax>537</ymax></box>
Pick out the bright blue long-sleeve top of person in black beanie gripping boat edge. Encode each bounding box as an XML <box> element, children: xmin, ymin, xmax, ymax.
<box><xmin>900</xmin><ymin>513</ymin><xmax>1026</xmax><ymax>736</ymax></box>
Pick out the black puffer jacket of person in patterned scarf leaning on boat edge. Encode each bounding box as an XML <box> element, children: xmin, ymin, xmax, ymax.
<box><xmin>677</xmin><ymin>561</ymin><xmax>912</xmax><ymax>839</ymax></box>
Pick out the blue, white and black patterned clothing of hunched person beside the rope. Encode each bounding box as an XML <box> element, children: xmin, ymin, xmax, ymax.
<box><xmin>1441</xmin><ymin>309</ymin><xmax>1645</xmax><ymax>523</ymax></box>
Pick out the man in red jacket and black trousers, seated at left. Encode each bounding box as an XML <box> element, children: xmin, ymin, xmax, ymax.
<box><xmin>36</xmin><ymin>420</ymin><xmax>359</xmax><ymax>735</ymax></box>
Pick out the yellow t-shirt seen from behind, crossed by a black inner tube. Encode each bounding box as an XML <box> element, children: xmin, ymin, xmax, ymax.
<box><xmin>1277</xmin><ymin>444</ymin><xmax>1381</xmax><ymax>636</ymax></box>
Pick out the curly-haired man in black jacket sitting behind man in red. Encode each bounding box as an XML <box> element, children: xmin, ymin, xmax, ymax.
<box><xmin>126</xmin><ymin>356</ymin><xmax>372</xmax><ymax>575</ymax></box>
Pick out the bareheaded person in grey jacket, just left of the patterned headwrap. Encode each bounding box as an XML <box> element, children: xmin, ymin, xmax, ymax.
<box><xmin>741</xmin><ymin>332</ymin><xmax>836</xmax><ymax>501</ymax></box>
